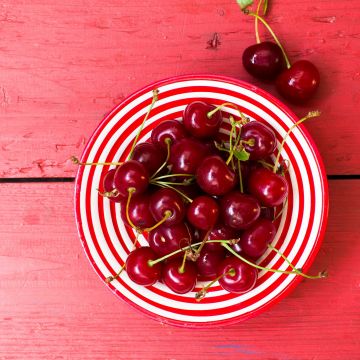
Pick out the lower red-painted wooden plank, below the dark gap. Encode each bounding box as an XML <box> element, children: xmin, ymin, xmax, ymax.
<box><xmin>0</xmin><ymin>180</ymin><xmax>360</xmax><ymax>360</ymax></box>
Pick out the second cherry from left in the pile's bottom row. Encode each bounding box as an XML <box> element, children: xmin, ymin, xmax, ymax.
<box><xmin>162</xmin><ymin>259</ymin><xmax>197</xmax><ymax>294</ymax></box>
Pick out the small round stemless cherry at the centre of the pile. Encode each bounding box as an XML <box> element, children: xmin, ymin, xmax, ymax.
<box><xmin>186</xmin><ymin>195</ymin><xmax>219</xmax><ymax>230</ymax></box>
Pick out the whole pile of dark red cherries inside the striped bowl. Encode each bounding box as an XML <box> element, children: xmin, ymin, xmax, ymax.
<box><xmin>97</xmin><ymin>101</ymin><xmax>296</xmax><ymax>299</ymax></box>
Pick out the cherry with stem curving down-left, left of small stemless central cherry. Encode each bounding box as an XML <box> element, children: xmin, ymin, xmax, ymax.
<box><xmin>149</xmin><ymin>188</ymin><xmax>185</xmax><ymax>225</ymax></box>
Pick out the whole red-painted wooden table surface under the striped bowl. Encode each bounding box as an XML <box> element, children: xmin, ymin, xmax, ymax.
<box><xmin>0</xmin><ymin>0</ymin><xmax>360</xmax><ymax>360</ymax></box>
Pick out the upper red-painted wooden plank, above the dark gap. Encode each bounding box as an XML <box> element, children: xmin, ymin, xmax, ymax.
<box><xmin>0</xmin><ymin>0</ymin><xmax>360</xmax><ymax>177</ymax></box>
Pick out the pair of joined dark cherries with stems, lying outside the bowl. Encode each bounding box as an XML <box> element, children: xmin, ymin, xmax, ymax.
<box><xmin>242</xmin><ymin>5</ymin><xmax>320</xmax><ymax>104</ymax></box>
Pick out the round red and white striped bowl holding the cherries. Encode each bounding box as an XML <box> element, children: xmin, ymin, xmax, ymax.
<box><xmin>75</xmin><ymin>75</ymin><xmax>328</xmax><ymax>327</ymax></box>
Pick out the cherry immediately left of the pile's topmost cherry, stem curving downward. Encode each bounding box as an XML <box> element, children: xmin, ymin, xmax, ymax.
<box><xmin>151</xmin><ymin>120</ymin><xmax>188</xmax><ymax>150</ymax></box>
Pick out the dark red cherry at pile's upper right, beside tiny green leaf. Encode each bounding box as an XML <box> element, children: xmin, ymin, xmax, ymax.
<box><xmin>240</xmin><ymin>121</ymin><xmax>276</xmax><ymax>160</ymax></box>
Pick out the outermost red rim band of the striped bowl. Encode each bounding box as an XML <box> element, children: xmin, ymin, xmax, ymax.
<box><xmin>73</xmin><ymin>73</ymin><xmax>329</xmax><ymax>329</ymax></box>
